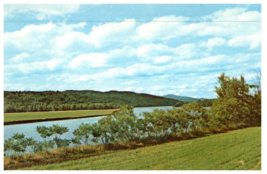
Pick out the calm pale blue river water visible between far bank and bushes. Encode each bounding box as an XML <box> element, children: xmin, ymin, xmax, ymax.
<box><xmin>4</xmin><ymin>106</ymin><xmax>176</xmax><ymax>141</ymax></box>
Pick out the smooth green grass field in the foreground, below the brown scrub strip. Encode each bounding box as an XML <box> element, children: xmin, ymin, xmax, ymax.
<box><xmin>24</xmin><ymin>127</ymin><xmax>261</xmax><ymax>170</ymax></box>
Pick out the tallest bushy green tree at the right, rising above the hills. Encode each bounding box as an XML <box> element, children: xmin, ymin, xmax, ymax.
<box><xmin>211</xmin><ymin>73</ymin><xmax>259</xmax><ymax>126</ymax></box>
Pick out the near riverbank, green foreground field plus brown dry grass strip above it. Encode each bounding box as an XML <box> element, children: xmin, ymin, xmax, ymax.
<box><xmin>4</xmin><ymin>127</ymin><xmax>261</xmax><ymax>170</ymax></box>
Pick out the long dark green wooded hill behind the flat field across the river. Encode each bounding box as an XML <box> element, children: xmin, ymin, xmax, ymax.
<box><xmin>4</xmin><ymin>90</ymin><xmax>183</xmax><ymax>112</ymax></box>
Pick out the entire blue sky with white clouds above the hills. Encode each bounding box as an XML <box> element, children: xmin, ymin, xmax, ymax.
<box><xmin>4</xmin><ymin>4</ymin><xmax>261</xmax><ymax>98</ymax></box>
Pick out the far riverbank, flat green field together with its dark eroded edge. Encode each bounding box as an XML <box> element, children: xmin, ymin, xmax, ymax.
<box><xmin>4</xmin><ymin>109</ymin><xmax>118</xmax><ymax>125</ymax></box>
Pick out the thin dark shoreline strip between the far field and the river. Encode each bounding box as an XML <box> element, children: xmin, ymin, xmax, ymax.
<box><xmin>4</xmin><ymin>111</ymin><xmax>118</xmax><ymax>126</ymax></box>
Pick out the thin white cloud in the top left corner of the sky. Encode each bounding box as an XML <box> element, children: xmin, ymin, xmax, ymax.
<box><xmin>4</xmin><ymin>4</ymin><xmax>80</xmax><ymax>20</ymax></box>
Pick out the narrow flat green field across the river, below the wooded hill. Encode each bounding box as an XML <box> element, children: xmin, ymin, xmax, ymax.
<box><xmin>4</xmin><ymin>109</ymin><xmax>116</xmax><ymax>123</ymax></box>
